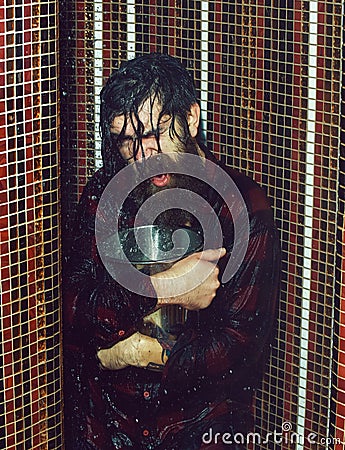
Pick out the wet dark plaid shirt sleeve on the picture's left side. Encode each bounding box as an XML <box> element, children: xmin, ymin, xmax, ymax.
<box><xmin>64</xmin><ymin>172</ymin><xmax>157</xmax><ymax>353</ymax></box>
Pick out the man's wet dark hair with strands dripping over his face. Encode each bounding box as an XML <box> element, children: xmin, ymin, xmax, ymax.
<box><xmin>100</xmin><ymin>53</ymin><xmax>197</xmax><ymax>175</ymax></box>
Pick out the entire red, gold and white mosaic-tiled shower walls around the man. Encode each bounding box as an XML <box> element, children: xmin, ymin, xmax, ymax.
<box><xmin>0</xmin><ymin>0</ymin><xmax>345</xmax><ymax>450</ymax></box>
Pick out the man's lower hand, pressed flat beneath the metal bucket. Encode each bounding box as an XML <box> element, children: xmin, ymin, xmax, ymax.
<box><xmin>97</xmin><ymin>332</ymin><xmax>167</xmax><ymax>370</ymax></box>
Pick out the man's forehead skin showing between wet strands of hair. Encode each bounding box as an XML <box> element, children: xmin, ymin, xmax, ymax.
<box><xmin>110</xmin><ymin>98</ymin><xmax>168</xmax><ymax>135</ymax></box>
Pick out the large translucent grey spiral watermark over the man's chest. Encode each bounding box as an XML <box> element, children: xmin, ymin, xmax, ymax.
<box><xmin>95</xmin><ymin>154</ymin><xmax>249</xmax><ymax>296</ymax></box>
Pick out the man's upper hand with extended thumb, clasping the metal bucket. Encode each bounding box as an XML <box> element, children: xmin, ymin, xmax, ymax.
<box><xmin>151</xmin><ymin>248</ymin><xmax>226</xmax><ymax>310</ymax></box>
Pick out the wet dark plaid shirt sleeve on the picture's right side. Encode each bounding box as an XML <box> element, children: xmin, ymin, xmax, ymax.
<box><xmin>160</xmin><ymin>206</ymin><xmax>280</xmax><ymax>395</ymax></box>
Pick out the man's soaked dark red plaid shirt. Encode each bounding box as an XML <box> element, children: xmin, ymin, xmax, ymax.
<box><xmin>64</xmin><ymin>149</ymin><xmax>280</xmax><ymax>450</ymax></box>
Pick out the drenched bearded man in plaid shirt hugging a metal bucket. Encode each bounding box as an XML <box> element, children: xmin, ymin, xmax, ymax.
<box><xmin>64</xmin><ymin>54</ymin><xmax>280</xmax><ymax>450</ymax></box>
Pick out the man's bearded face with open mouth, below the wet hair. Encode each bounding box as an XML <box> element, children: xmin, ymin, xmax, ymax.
<box><xmin>111</xmin><ymin>100</ymin><xmax>207</xmax><ymax>227</ymax></box>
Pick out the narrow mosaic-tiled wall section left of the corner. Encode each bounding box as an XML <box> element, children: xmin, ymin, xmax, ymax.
<box><xmin>0</xmin><ymin>0</ymin><xmax>62</xmax><ymax>450</ymax></box>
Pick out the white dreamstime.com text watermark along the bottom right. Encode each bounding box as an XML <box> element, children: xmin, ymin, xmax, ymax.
<box><xmin>202</xmin><ymin>422</ymin><xmax>343</xmax><ymax>448</ymax></box>
